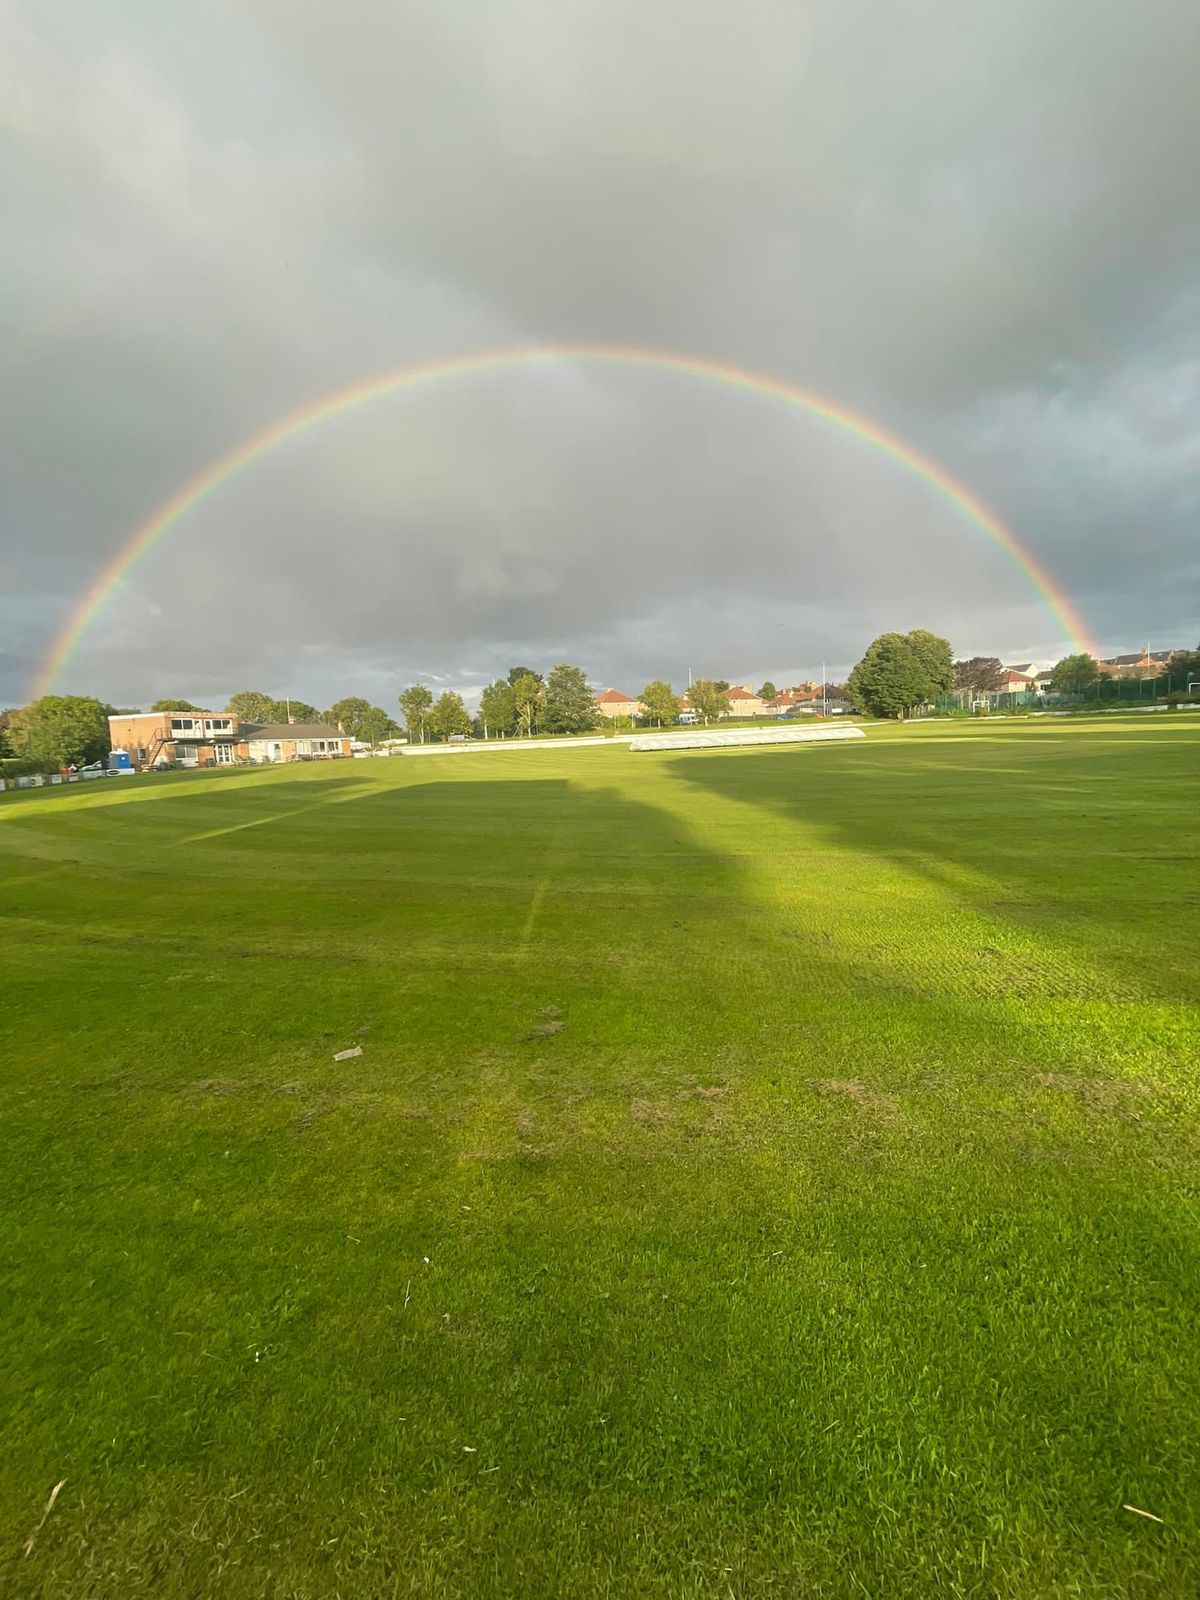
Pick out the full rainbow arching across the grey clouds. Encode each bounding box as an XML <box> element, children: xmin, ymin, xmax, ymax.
<box><xmin>34</xmin><ymin>344</ymin><xmax>1094</xmax><ymax>698</ymax></box>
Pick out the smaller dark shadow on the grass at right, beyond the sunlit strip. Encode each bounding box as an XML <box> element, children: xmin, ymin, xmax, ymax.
<box><xmin>670</xmin><ymin>730</ymin><xmax>1200</xmax><ymax>1000</ymax></box>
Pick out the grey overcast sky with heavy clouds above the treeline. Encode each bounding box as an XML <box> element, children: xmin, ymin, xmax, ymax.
<box><xmin>0</xmin><ymin>0</ymin><xmax>1200</xmax><ymax>709</ymax></box>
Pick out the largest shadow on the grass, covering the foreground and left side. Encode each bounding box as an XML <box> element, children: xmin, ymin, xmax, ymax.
<box><xmin>0</xmin><ymin>764</ymin><xmax>1195</xmax><ymax>1600</ymax></box>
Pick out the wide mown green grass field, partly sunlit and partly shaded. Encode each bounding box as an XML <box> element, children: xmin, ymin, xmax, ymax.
<box><xmin>0</xmin><ymin>715</ymin><xmax>1200</xmax><ymax>1600</ymax></box>
